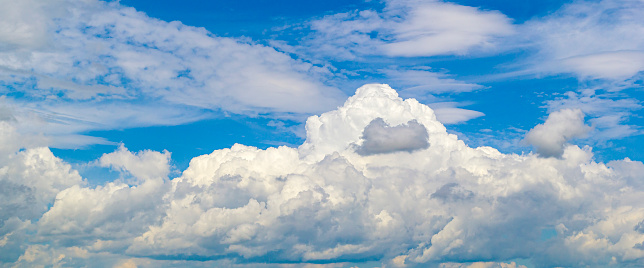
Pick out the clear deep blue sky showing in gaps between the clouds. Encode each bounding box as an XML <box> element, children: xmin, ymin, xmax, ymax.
<box><xmin>40</xmin><ymin>1</ymin><xmax>642</xmax><ymax>170</ymax></box>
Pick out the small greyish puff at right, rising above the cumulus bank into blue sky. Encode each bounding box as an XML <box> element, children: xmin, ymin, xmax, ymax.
<box><xmin>525</xmin><ymin>109</ymin><xmax>592</xmax><ymax>157</ymax></box>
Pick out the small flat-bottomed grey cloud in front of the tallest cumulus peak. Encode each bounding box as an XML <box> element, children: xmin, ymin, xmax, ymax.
<box><xmin>356</xmin><ymin>117</ymin><xmax>429</xmax><ymax>155</ymax></box>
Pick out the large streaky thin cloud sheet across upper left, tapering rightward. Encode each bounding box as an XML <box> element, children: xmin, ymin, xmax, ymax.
<box><xmin>0</xmin><ymin>0</ymin><xmax>345</xmax><ymax>148</ymax></box>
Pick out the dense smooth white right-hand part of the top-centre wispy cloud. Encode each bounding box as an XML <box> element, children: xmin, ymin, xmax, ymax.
<box><xmin>383</xmin><ymin>0</ymin><xmax>513</xmax><ymax>57</ymax></box>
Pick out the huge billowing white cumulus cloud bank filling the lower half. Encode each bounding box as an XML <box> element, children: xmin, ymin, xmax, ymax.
<box><xmin>0</xmin><ymin>84</ymin><xmax>644</xmax><ymax>267</ymax></box>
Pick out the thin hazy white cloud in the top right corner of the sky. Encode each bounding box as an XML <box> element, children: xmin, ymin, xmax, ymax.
<box><xmin>521</xmin><ymin>0</ymin><xmax>644</xmax><ymax>80</ymax></box>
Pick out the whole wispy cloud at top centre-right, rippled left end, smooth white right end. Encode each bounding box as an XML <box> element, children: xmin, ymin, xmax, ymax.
<box><xmin>296</xmin><ymin>0</ymin><xmax>514</xmax><ymax>60</ymax></box>
